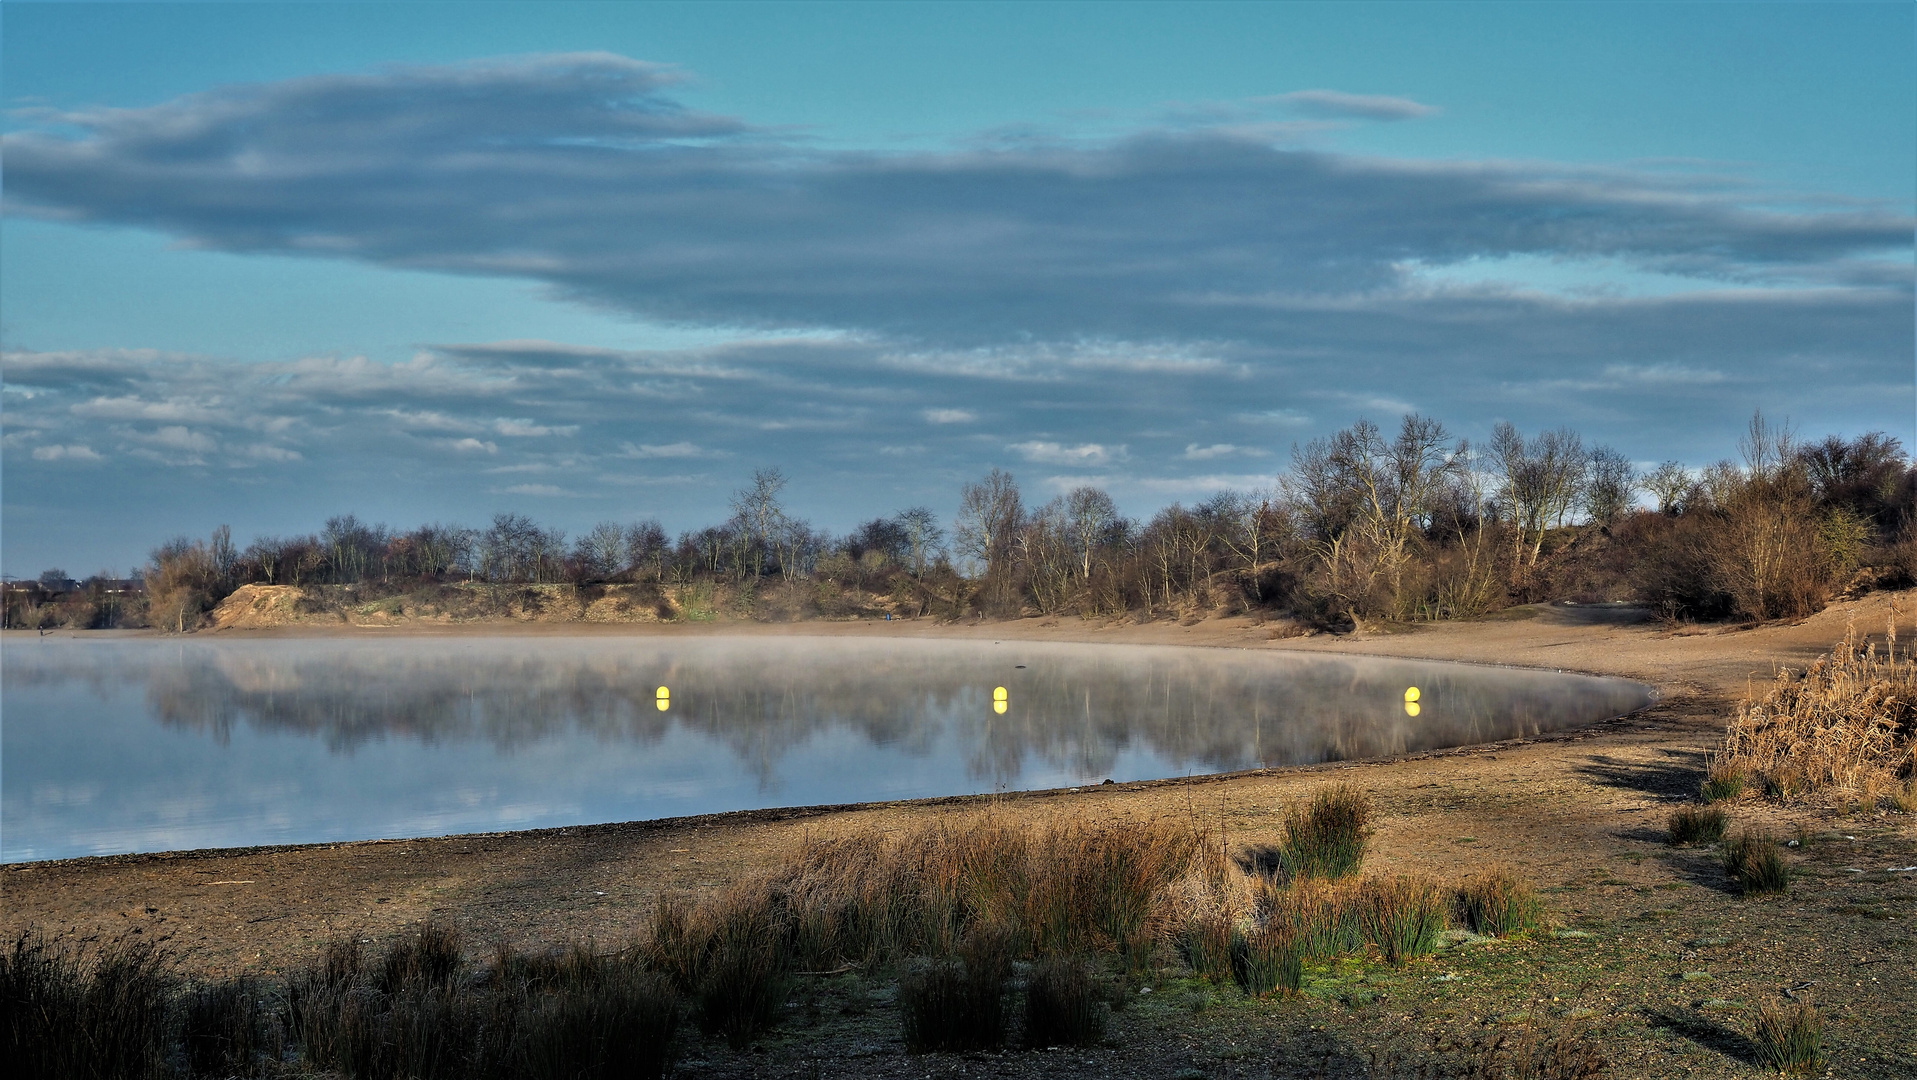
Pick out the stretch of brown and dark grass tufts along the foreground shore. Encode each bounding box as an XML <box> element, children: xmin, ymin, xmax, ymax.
<box><xmin>0</xmin><ymin>787</ymin><xmax>1601</xmax><ymax>1080</ymax></box>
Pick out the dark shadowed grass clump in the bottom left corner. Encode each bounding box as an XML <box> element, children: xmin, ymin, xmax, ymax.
<box><xmin>0</xmin><ymin>930</ymin><xmax>173</xmax><ymax>1080</ymax></box>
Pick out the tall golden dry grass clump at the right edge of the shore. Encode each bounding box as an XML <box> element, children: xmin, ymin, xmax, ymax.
<box><xmin>1725</xmin><ymin>614</ymin><xmax>1917</xmax><ymax>802</ymax></box>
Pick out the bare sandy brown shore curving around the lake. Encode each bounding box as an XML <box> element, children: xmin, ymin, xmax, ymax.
<box><xmin>0</xmin><ymin>593</ymin><xmax>1917</xmax><ymax>1078</ymax></box>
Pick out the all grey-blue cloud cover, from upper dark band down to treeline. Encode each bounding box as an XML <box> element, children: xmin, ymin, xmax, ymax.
<box><xmin>0</xmin><ymin>54</ymin><xmax>1917</xmax><ymax>574</ymax></box>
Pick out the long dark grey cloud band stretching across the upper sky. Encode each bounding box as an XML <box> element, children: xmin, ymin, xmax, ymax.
<box><xmin>4</xmin><ymin>54</ymin><xmax>1911</xmax><ymax>354</ymax></box>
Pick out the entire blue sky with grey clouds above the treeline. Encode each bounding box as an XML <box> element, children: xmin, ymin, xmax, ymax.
<box><xmin>0</xmin><ymin>0</ymin><xmax>1917</xmax><ymax>575</ymax></box>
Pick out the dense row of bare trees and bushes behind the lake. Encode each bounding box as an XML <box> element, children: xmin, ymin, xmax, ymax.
<box><xmin>8</xmin><ymin>414</ymin><xmax>1917</xmax><ymax>629</ymax></box>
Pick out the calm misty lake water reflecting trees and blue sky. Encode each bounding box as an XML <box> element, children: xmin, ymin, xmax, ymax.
<box><xmin>0</xmin><ymin>637</ymin><xmax>1649</xmax><ymax>861</ymax></box>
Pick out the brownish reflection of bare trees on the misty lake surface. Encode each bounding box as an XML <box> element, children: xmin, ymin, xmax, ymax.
<box><xmin>119</xmin><ymin>639</ymin><xmax>1645</xmax><ymax>787</ymax></box>
